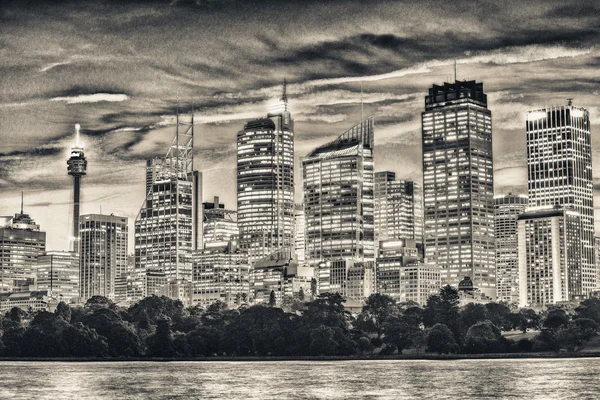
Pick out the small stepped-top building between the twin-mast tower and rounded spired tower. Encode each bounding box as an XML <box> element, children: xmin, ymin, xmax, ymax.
<box><xmin>202</xmin><ymin>196</ymin><xmax>240</xmax><ymax>247</ymax></box>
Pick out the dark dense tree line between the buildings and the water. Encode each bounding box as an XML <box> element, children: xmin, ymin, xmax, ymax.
<box><xmin>0</xmin><ymin>286</ymin><xmax>600</xmax><ymax>357</ymax></box>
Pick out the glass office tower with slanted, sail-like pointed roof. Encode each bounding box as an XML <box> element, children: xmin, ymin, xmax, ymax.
<box><xmin>302</xmin><ymin>117</ymin><xmax>375</xmax><ymax>266</ymax></box>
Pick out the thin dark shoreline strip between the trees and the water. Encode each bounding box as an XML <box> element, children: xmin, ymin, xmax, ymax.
<box><xmin>0</xmin><ymin>352</ymin><xmax>600</xmax><ymax>363</ymax></box>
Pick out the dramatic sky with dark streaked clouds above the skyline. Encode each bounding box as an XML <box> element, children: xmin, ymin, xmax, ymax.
<box><xmin>0</xmin><ymin>0</ymin><xmax>600</xmax><ymax>251</ymax></box>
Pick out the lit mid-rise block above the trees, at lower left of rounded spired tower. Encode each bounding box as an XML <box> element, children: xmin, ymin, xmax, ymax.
<box><xmin>192</xmin><ymin>236</ymin><xmax>250</xmax><ymax>308</ymax></box>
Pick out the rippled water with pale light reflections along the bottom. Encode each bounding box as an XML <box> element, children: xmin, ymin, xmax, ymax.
<box><xmin>0</xmin><ymin>358</ymin><xmax>600</xmax><ymax>400</ymax></box>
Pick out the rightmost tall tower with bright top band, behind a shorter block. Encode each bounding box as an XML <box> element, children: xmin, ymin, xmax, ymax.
<box><xmin>526</xmin><ymin>100</ymin><xmax>596</xmax><ymax>297</ymax></box>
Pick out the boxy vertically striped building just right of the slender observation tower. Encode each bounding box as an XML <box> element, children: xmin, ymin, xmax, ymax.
<box><xmin>79</xmin><ymin>214</ymin><xmax>129</xmax><ymax>302</ymax></box>
